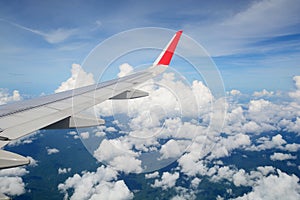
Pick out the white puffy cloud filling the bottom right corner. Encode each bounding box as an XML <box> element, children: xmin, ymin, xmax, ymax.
<box><xmin>236</xmin><ymin>170</ymin><xmax>300</xmax><ymax>200</ymax></box>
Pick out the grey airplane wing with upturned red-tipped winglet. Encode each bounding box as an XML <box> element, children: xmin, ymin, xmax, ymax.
<box><xmin>0</xmin><ymin>31</ymin><xmax>182</xmax><ymax>169</ymax></box>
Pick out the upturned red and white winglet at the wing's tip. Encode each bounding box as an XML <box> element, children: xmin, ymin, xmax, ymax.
<box><xmin>153</xmin><ymin>30</ymin><xmax>182</xmax><ymax>65</ymax></box>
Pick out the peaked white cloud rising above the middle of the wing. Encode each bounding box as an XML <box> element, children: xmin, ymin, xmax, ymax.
<box><xmin>55</xmin><ymin>63</ymin><xmax>95</xmax><ymax>93</ymax></box>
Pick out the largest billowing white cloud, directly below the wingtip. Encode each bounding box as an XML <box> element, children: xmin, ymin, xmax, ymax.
<box><xmin>96</xmin><ymin>69</ymin><xmax>213</xmax><ymax>120</ymax></box>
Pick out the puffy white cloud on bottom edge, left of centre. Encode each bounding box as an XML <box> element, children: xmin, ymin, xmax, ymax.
<box><xmin>58</xmin><ymin>166</ymin><xmax>133</xmax><ymax>200</ymax></box>
